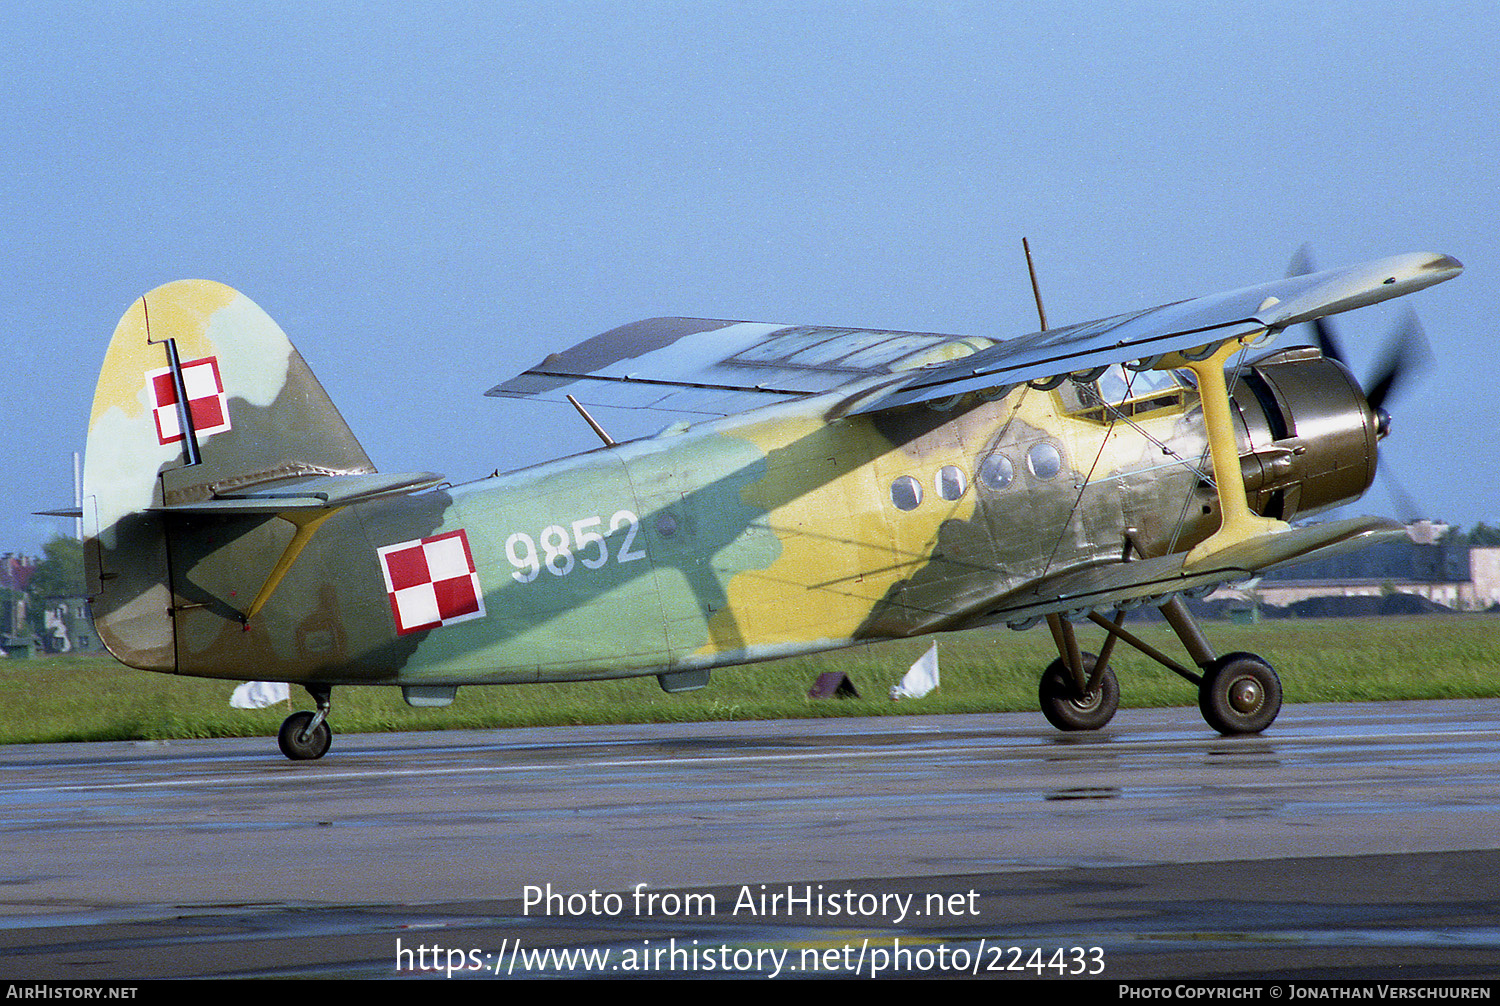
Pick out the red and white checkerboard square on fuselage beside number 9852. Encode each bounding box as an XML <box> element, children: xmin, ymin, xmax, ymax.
<box><xmin>377</xmin><ymin>528</ymin><xmax>485</xmax><ymax>636</ymax></box>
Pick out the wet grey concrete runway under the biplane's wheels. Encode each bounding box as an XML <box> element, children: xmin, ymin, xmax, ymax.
<box><xmin>0</xmin><ymin>700</ymin><xmax>1500</xmax><ymax>981</ymax></box>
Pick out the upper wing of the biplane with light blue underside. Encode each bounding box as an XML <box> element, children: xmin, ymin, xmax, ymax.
<box><xmin>488</xmin><ymin>253</ymin><xmax>1463</xmax><ymax>415</ymax></box>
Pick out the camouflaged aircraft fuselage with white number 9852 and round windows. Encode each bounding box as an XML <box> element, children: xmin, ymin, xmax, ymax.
<box><xmin>158</xmin><ymin>350</ymin><xmax>1373</xmax><ymax>685</ymax></box>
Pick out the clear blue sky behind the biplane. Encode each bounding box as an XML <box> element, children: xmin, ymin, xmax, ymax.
<box><xmin>0</xmin><ymin>0</ymin><xmax>1500</xmax><ymax>552</ymax></box>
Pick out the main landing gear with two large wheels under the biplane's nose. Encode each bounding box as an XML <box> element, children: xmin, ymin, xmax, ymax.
<box><xmin>1040</xmin><ymin>597</ymin><xmax>1281</xmax><ymax>735</ymax></box>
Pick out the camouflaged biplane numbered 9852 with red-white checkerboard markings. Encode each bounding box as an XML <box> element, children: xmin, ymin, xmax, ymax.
<box><xmin>84</xmin><ymin>253</ymin><xmax>1463</xmax><ymax>759</ymax></box>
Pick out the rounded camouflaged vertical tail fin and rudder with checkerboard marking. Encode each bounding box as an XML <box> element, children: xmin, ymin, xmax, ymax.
<box><xmin>84</xmin><ymin>280</ymin><xmax>375</xmax><ymax>670</ymax></box>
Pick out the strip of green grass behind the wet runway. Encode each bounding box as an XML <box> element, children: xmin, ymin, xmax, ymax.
<box><xmin>0</xmin><ymin>615</ymin><xmax>1500</xmax><ymax>744</ymax></box>
